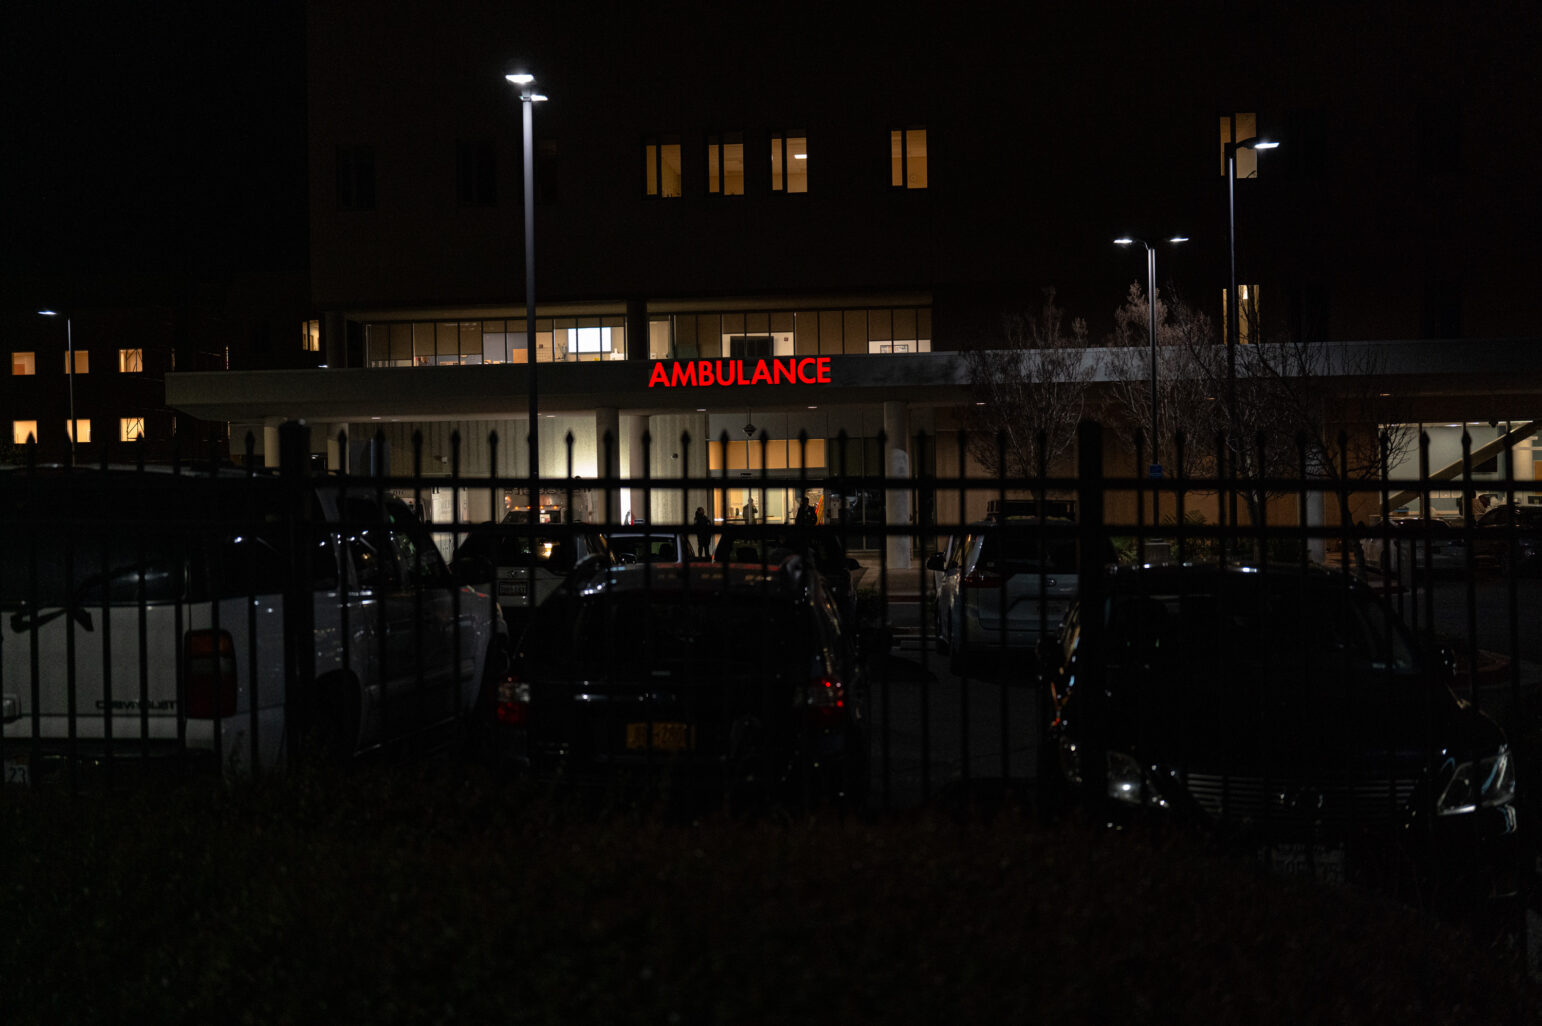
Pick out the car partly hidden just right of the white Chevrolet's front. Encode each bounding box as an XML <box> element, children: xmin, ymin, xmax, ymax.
<box><xmin>450</xmin><ymin>514</ymin><xmax>615</xmax><ymax>637</ymax></box>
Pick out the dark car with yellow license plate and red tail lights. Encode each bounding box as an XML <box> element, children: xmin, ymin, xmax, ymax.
<box><xmin>497</xmin><ymin>557</ymin><xmax>868</xmax><ymax>802</ymax></box>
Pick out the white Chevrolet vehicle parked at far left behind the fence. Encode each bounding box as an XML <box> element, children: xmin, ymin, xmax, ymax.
<box><xmin>0</xmin><ymin>467</ymin><xmax>507</xmax><ymax>784</ymax></box>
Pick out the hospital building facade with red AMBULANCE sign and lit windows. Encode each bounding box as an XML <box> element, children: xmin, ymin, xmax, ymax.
<box><xmin>15</xmin><ymin>0</ymin><xmax>1542</xmax><ymax>543</ymax></box>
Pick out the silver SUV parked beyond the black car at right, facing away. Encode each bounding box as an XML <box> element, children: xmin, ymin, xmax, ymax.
<box><xmin>927</xmin><ymin>517</ymin><xmax>1115</xmax><ymax>673</ymax></box>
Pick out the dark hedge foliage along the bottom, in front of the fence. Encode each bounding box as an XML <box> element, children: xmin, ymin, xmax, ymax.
<box><xmin>0</xmin><ymin>767</ymin><xmax>1539</xmax><ymax>1024</ymax></box>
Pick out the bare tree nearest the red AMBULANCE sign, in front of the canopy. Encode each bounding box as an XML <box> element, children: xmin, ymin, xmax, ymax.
<box><xmin>965</xmin><ymin>289</ymin><xmax>1092</xmax><ymax>477</ymax></box>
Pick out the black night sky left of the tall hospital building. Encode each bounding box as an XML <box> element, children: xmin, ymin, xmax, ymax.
<box><xmin>0</xmin><ymin>0</ymin><xmax>305</xmax><ymax>305</ymax></box>
